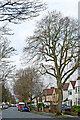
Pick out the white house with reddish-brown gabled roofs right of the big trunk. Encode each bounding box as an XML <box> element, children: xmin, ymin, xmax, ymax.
<box><xmin>63</xmin><ymin>77</ymin><xmax>80</xmax><ymax>106</ymax></box>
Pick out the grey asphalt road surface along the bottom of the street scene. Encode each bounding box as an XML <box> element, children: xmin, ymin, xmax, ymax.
<box><xmin>2</xmin><ymin>107</ymin><xmax>80</xmax><ymax>120</ymax></box>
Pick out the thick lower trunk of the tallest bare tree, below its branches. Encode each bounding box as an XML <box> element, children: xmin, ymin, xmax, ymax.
<box><xmin>57</xmin><ymin>88</ymin><xmax>63</xmax><ymax>114</ymax></box>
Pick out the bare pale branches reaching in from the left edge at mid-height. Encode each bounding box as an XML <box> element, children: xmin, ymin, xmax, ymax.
<box><xmin>0</xmin><ymin>26</ymin><xmax>15</xmax><ymax>81</ymax></box>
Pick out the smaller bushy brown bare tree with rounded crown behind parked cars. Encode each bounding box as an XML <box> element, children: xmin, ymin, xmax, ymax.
<box><xmin>14</xmin><ymin>68</ymin><xmax>43</xmax><ymax>107</ymax></box>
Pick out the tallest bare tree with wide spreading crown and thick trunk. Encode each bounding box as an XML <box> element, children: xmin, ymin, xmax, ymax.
<box><xmin>24</xmin><ymin>11</ymin><xmax>79</xmax><ymax>113</ymax></box>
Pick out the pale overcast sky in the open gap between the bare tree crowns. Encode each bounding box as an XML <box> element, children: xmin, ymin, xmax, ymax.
<box><xmin>5</xmin><ymin>0</ymin><xmax>80</xmax><ymax>76</ymax></box>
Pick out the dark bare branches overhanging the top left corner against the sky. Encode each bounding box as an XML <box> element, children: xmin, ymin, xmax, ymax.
<box><xmin>0</xmin><ymin>0</ymin><xmax>46</xmax><ymax>23</ymax></box>
